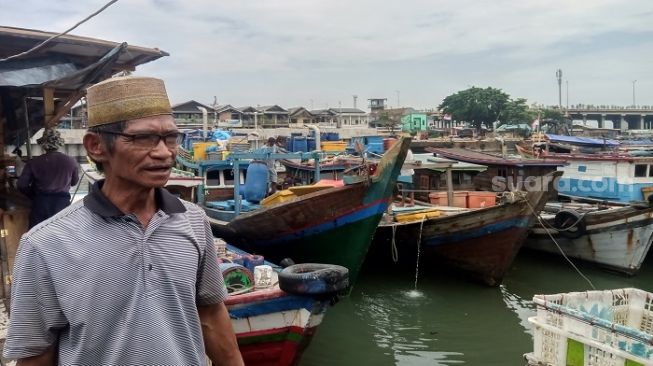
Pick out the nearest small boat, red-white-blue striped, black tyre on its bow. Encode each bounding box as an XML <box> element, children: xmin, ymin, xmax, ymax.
<box><xmin>222</xmin><ymin>243</ymin><xmax>347</xmax><ymax>366</ymax></box>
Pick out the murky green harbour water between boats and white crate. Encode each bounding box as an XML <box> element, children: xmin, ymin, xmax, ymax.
<box><xmin>300</xmin><ymin>246</ymin><xmax>653</xmax><ymax>366</ymax></box>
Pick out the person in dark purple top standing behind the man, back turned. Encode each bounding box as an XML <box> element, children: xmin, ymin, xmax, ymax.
<box><xmin>17</xmin><ymin>129</ymin><xmax>79</xmax><ymax>228</ymax></box>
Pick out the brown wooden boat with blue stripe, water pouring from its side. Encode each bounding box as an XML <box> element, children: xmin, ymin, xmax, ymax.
<box><xmin>375</xmin><ymin>172</ymin><xmax>560</xmax><ymax>286</ymax></box>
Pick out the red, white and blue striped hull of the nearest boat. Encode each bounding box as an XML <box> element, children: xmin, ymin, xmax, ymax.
<box><xmin>226</xmin><ymin>287</ymin><xmax>329</xmax><ymax>366</ymax></box>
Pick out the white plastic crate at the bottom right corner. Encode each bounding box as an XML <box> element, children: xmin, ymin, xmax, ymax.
<box><xmin>526</xmin><ymin>288</ymin><xmax>653</xmax><ymax>366</ymax></box>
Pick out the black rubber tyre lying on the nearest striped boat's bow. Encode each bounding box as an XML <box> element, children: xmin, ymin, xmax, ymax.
<box><xmin>279</xmin><ymin>263</ymin><xmax>349</xmax><ymax>295</ymax></box>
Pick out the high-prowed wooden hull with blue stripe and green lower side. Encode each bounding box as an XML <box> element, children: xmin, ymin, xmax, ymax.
<box><xmin>210</xmin><ymin>138</ymin><xmax>410</xmax><ymax>284</ymax></box>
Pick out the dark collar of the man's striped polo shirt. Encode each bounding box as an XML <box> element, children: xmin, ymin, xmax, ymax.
<box><xmin>84</xmin><ymin>179</ymin><xmax>186</xmax><ymax>217</ymax></box>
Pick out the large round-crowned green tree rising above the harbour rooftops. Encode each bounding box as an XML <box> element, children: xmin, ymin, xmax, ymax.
<box><xmin>438</xmin><ymin>87</ymin><xmax>509</xmax><ymax>130</ymax></box>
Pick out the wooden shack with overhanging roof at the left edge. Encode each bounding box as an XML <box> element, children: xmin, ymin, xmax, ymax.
<box><xmin>0</xmin><ymin>27</ymin><xmax>168</xmax><ymax>299</ymax></box>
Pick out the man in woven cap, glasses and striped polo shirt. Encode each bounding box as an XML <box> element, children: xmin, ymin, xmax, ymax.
<box><xmin>4</xmin><ymin>77</ymin><xmax>243</xmax><ymax>365</ymax></box>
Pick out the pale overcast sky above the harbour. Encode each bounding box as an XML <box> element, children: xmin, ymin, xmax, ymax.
<box><xmin>0</xmin><ymin>0</ymin><xmax>653</xmax><ymax>109</ymax></box>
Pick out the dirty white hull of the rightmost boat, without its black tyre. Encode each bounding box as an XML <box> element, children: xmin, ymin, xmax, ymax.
<box><xmin>526</xmin><ymin>207</ymin><xmax>653</xmax><ymax>275</ymax></box>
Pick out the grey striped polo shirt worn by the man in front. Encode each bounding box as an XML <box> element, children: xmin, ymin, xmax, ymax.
<box><xmin>4</xmin><ymin>182</ymin><xmax>227</xmax><ymax>365</ymax></box>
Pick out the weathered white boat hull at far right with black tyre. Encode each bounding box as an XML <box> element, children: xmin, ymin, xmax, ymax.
<box><xmin>526</xmin><ymin>203</ymin><xmax>653</xmax><ymax>275</ymax></box>
